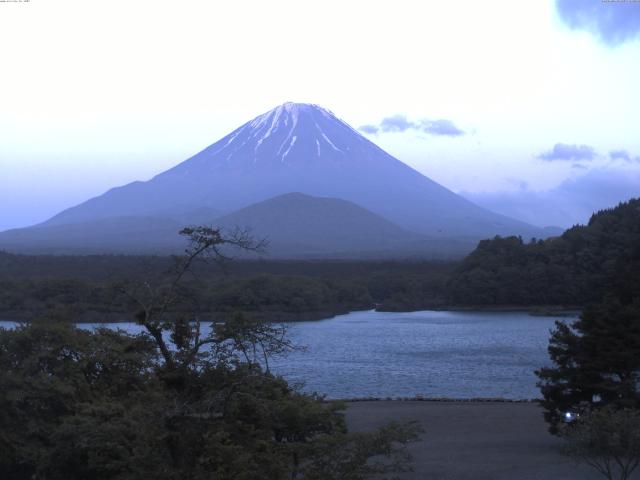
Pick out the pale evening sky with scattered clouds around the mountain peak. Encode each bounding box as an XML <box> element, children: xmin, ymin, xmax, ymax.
<box><xmin>0</xmin><ymin>0</ymin><xmax>640</xmax><ymax>230</ymax></box>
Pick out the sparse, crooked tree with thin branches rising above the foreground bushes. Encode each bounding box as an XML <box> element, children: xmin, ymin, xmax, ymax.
<box><xmin>122</xmin><ymin>226</ymin><xmax>294</xmax><ymax>371</ymax></box>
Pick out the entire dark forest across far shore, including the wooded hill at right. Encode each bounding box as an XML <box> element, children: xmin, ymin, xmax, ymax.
<box><xmin>0</xmin><ymin>199</ymin><xmax>640</xmax><ymax>321</ymax></box>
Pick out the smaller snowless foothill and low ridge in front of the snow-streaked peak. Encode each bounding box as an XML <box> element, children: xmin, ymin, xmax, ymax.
<box><xmin>0</xmin><ymin>193</ymin><xmax>475</xmax><ymax>258</ymax></box>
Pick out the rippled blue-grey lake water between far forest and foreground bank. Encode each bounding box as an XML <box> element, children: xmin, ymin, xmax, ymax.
<box><xmin>0</xmin><ymin>311</ymin><xmax>577</xmax><ymax>399</ymax></box>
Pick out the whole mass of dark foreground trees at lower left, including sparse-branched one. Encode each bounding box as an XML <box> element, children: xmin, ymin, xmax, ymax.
<box><xmin>0</xmin><ymin>227</ymin><xmax>418</xmax><ymax>480</ymax></box>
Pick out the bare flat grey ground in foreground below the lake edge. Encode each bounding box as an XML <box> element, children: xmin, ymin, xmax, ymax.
<box><xmin>347</xmin><ymin>400</ymin><xmax>608</xmax><ymax>480</ymax></box>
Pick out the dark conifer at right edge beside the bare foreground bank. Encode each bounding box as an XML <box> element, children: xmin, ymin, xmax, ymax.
<box><xmin>536</xmin><ymin>296</ymin><xmax>640</xmax><ymax>433</ymax></box>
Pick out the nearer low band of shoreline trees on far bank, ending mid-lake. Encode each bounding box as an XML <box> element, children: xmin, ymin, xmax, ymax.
<box><xmin>0</xmin><ymin>275</ymin><xmax>374</xmax><ymax>321</ymax></box>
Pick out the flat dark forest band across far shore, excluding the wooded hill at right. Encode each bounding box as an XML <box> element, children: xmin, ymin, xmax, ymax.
<box><xmin>0</xmin><ymin>253</ymin><xmax>455</xmax><ymax>321</ymax></box>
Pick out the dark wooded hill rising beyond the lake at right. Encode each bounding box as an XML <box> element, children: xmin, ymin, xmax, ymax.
<box><xmin>448</xmin><ymin>199</ymin><xmax>640</xmax><ymax>305</ymax></box>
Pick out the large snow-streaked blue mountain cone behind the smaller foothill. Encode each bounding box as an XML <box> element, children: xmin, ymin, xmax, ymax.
<box><xmin>38</xmin><ymin>103</ymin><xmax>546</xmax><ymax>239</ymax></box>
